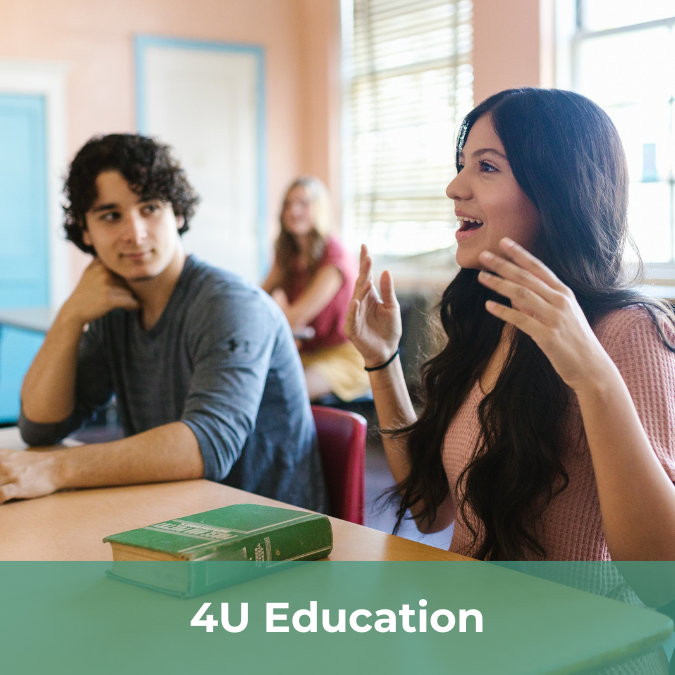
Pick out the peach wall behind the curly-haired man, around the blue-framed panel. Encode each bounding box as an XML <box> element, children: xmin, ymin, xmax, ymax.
<box><xmin>0</xmin><ymin>0</ymin><xmax>339</xmax><ymax>277</ymax></box>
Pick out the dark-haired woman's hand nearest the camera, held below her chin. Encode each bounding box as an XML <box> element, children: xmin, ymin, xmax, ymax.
<box><xmin>478</xmin><ymin>237</ymin><xmax>615</xmax><ymax>394</ymax></box>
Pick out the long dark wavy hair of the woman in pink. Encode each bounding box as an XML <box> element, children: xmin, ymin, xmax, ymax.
<box><xmin>393</xmin><ymin>89</ymin><xmax>675</xmax><ymax>560</ymax></box>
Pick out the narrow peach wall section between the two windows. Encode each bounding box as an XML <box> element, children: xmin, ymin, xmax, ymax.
<box><xmin>473</xmin><ymin>0</ymin><xmax>547</xmax><ymax>104</ymax></box>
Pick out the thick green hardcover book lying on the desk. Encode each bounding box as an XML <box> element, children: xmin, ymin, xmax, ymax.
<box><xmin>103</xmin><ymin>504</ymin><xmax>333</xmax><ymax>598</ymax></box>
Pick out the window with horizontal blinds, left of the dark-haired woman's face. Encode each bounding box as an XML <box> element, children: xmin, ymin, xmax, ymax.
<box><xmin>342</xmin><ymin>0</ymin><xmax>473</xmax><ymax>256</ymax></box>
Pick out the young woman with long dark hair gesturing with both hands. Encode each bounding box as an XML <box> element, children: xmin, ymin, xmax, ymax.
<box><xmin>345</xmin><ymin>89</ymin><xmax>675</xmax><ymax>560</ymax></box>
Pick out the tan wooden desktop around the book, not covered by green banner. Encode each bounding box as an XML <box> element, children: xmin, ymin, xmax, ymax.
<box><xmin>0</xmin><ymin>427</ymin><xmax>467</xmax><ymax>560</ymax></box>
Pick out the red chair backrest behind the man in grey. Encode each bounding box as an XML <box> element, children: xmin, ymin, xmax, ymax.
<box><xmin>312</xmin><ymin>406</ymin><xmax>367</xmax><ymax>525</ymax></box>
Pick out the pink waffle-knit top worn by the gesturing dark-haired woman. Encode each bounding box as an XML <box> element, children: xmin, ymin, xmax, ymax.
<box><xmin>443</xmin><ymin>306</ymin><xmax>675</xmax><ymax>560</ymax></box>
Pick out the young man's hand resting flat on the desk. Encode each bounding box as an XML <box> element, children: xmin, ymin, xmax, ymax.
<box><xmin>0</xmin><ymin>450</ymin><xmax>60</xmax><ymax>504</ymax></box>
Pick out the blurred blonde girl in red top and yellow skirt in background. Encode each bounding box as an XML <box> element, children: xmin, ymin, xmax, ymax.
<box><xmin>263</xmin><ymin>176</ymin><xmax>370</xmax><ymax>401</ymax></box>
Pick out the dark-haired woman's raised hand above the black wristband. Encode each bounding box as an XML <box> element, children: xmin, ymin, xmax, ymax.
<box><xmin>344</xmin><ymin>244</ymin><xmax>401</xmax><ymax>368</ymax></box>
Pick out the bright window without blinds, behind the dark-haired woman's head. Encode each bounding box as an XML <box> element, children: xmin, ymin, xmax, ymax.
<box><xmin>573</xmin><ymin>0</ymin><xmax>675</xmax><ymax>268</ymax></box>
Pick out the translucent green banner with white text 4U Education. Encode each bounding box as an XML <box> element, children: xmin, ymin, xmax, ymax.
<box><xmin>0</xmin><ymin>562</ymin><xmax>675</xmax><ymax>675</ymax></box>
